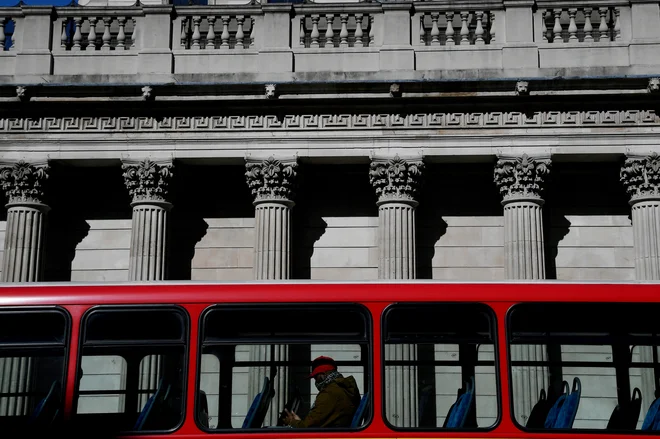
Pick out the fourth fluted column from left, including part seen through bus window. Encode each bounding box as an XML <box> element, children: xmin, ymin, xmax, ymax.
<box><xmin>369</xmin><ymin>155</ymin><xmax>424</xmax><ymax>427</ymax></box>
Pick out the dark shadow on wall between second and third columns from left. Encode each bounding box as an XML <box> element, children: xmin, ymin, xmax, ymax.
<box><xmin>168</xmin><ymin>163</ymin><xmax>254</xmax><ymax>280</ymax></box>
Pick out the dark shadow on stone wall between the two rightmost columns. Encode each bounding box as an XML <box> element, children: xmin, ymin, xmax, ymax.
<box><xmin>543</xmin><ymin>162</ymin><xmax>630</xmax><ymax>279</ymax></box>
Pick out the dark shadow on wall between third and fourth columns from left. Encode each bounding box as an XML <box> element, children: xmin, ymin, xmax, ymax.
<box><xmin>291</xmin><ymin>163</ymin><xmax>378</xmax><ymax>279</ymax></box>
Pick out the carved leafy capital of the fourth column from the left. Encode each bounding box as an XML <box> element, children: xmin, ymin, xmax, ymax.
<box><xmin>369</xmin><ymin>154</ymin><xmax>425</xmax><ymax>205</ymax></box>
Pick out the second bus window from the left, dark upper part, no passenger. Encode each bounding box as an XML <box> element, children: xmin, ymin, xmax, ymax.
<box><xmin>76</xmin><ymin>306</ymin><xmax>188</xmax><ymax>431</ymax></box>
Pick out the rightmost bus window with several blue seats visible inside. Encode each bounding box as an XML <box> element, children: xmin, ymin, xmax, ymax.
<box><xmin>507</xmin><ymin>303</ymin><xmax>660</xmax><ymax>432</ymax></box>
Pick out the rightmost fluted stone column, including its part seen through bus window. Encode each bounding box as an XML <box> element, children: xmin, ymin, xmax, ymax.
<box><xmin>620</xmin><ymin>152</ymin><xmax>660</xmax><ymax>413</ymax></box>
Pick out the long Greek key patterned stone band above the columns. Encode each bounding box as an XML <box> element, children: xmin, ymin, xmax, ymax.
<box><xmin>0</xmin><ymin>110</ymin><xmax>660</xmax><ymax>133</ymax></box>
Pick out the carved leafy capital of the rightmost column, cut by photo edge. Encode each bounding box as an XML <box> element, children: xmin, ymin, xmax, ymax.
<box><xmin>619</xmin><ymin>152</ymin><xmax>660</xmax><ymax>204</ymax></box>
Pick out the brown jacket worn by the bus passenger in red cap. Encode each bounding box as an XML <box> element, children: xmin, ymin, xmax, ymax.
<box><xmin>290</xmin><ymin>376</ymin><xmax>360</xmax><ymax>428</ymax></box>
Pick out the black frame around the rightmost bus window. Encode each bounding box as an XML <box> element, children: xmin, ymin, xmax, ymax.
<box><xmin>504</xmin><ymin>300</ymin><xmax>660</xmax><ymax>436</ymax></box>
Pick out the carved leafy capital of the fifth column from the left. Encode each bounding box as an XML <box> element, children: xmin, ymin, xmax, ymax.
<box><xmin>494</xmin><ymin>154</ymin><xmax>551</xmax><ymax>204</ymax></box>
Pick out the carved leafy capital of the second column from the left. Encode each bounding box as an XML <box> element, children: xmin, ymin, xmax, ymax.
<box><xmin>122</xmin><ymin>159</ymin><xmax>174</xmax><ymax>204</ymax></box>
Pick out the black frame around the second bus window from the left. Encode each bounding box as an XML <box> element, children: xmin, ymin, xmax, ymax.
<box><xmin>77</xmin><ymin>303</ymin><xmax>192</xmax><ymax>437</ymax></box>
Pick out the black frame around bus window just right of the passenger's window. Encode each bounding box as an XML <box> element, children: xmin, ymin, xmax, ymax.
<box><xmin>380</xmin><ymin>301</ymin><xmax>503</xmax><ymax>434</ymax></box>
